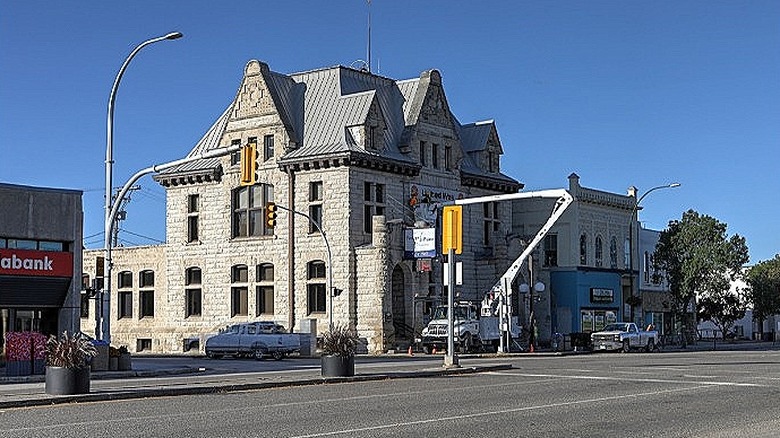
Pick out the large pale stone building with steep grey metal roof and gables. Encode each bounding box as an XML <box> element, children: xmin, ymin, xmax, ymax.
<box><xmin>83</xmin><ymin>61</ymin><xmax>522</xmax><ymax>352</ymax></box>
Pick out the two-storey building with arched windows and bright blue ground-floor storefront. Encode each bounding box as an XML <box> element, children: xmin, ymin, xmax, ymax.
<box><xmin>511</xmin><ymin>173</ymin><xmax>637</xmax><ymax>343</ymax></box>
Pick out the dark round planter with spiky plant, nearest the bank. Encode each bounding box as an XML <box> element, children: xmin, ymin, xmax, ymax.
<box><xmin>44</xmin><ymin>332</ymin><xmax>97</xmax><ymax>395</ymax></box>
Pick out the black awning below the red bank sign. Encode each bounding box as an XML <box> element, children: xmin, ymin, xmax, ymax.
<box><xmin>0</xmin><ymin>275</ymin><xmax>71</xmax><ymax>308</ymax></box>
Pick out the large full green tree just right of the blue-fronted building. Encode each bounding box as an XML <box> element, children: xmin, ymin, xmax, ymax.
<box><xmin>654</xmin><ymin>210</ymin><xmax>748</xmax><ymax>344</ymax></box>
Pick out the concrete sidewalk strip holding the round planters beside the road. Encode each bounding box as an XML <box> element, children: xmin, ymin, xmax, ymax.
<box><xmin>0</xmin><ymin>363</ymin><xmax>512</xmax><ymax>409</ymax></box>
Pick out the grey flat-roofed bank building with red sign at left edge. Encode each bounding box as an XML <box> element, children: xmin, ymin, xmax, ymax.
<box><xmin>0</xmin><ymin>183</ymin><xmax>87</xmax><ymax>350</ymax></box>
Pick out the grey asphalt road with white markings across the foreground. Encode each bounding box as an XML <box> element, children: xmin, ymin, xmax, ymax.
<box><xmin>0</xmin><ymin>351</ymin><xmax>780</xmax><ymax>438</ymax></box>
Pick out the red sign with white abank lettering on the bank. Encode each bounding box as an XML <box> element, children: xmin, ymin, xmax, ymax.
<box><xmin>0</xmin><ymin>249</ymin><xmax>73</xmax><ymax>277</ymax></box>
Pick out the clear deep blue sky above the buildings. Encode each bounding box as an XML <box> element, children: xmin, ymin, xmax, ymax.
<box><xmin>0</xmin><ymin>0</ymin><xmax>780</xmax><ymax>262</ymax></box>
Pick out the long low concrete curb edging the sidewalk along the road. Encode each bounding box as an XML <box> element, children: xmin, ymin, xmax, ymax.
<box><xmin>0</xmin><ymin>364</ymin><xmax>512</xmax><ymax>409</ymax></box>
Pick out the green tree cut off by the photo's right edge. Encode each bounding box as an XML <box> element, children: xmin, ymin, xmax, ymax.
<box><xmin>746</xmin><ymin>254</ymin><xmax>780</xmax><ymax>336</ymax></box>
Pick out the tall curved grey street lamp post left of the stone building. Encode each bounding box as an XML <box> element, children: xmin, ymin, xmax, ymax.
<box><xmin>102</xmin><ymin>32</ymin><xmax>182</xmax><ymax>342</ymax></box>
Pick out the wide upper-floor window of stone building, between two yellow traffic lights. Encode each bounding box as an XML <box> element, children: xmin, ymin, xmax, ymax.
<box><xmin>233</xmin><ymin>184</ymin><xmax>274</xmax><ymax>237</ymax></box>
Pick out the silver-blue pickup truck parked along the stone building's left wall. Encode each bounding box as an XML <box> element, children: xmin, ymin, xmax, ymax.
<box><xmin>205</xmin><ymin>321</ymin><xmax>301</xmax><ymax>360</ymax></box>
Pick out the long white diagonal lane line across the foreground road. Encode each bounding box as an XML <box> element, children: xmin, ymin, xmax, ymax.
<box><xmin>291</xmin><ymin>385</ymin><xmax>708</xmax><ymax>438</ymax></box>
